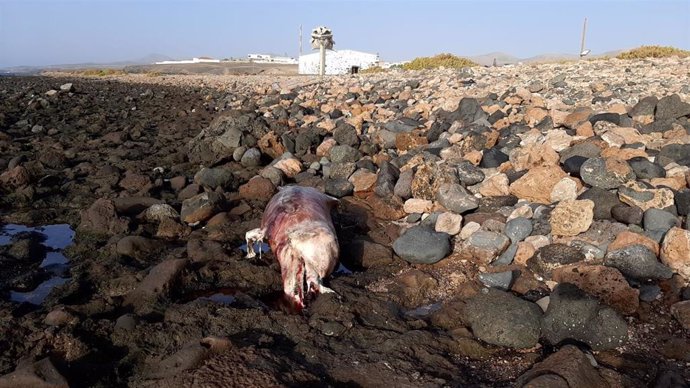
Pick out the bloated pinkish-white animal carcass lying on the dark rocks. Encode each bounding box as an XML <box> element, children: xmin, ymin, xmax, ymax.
<box><xmin>247</xmin><ymin>186</ymin><xmax>339</xmax><ymax>308</ymax></box>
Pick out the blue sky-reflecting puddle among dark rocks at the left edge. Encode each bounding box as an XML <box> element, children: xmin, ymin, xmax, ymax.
<box><xmin>0</xmin><ymin>224</ymin><xmax>74</xmax><ymax>305</ymax></box>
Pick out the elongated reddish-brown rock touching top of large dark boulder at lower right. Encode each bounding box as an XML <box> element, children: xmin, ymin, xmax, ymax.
<box><xmin>552</xmin><ymin>264</ymin><xmax>640</xmax><ymax>314</ymax></box>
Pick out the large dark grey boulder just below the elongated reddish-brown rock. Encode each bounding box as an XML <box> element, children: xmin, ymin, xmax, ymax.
<box><xmin>541</xmin><ymin>283</ymin><xmax>628</xmax><ymax>350</ymax></box>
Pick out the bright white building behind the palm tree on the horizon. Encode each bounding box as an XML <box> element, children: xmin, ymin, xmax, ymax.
<box><xmin>299</xmin><ymin>50</ymin><xmax>379</xmax><ymax>75</ymax></box>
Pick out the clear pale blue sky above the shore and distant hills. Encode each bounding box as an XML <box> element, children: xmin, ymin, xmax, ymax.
<box><xmin>0</xmin><ymin>0</ymin><xmax>690</xmax><ymax>67</ymax></box>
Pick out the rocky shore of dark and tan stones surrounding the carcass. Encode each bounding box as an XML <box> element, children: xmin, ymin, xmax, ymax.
<box><xmin>0</xmin><ymin>58</ymin><xmax>690</xmax><ymax>387</ymax></box>
